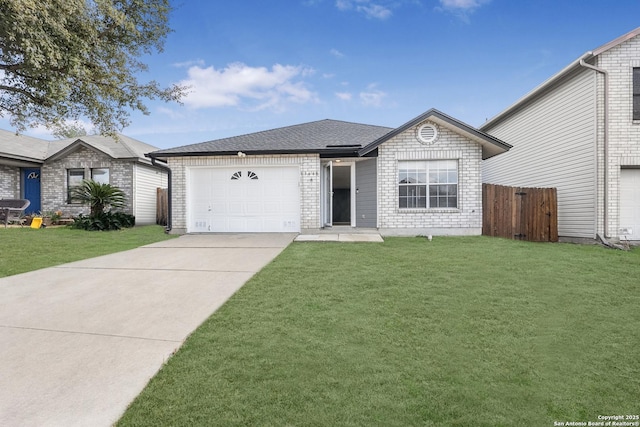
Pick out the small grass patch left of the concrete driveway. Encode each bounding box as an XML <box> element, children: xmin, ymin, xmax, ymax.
<box><xmin>0</xmin><ymin>225</ymin><xmax>175</xmax><ymax>277</ymax></box>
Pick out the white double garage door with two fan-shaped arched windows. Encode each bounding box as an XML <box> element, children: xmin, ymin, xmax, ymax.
<box><xmin>187</xmin><ymin>166</ymin><xmax>300</xmax><ymax>233</ymax></box>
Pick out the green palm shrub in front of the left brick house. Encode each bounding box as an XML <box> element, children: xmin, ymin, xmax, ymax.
<box><xmin>71</xmin><ymin>179</ymin><xmax>135</xmax><ymax>230</ymax></box>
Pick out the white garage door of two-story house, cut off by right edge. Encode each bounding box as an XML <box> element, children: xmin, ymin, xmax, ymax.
<box><xmin>620</xmin><ymin>169</ymin><xmax>640</xmax><ymax>240</ymax></box>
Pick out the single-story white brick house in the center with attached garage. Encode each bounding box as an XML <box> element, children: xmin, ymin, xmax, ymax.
<box><xmin>149</xmin><ymin>109</ymin><xmax>510</xmax><ymax>235</ymax></box>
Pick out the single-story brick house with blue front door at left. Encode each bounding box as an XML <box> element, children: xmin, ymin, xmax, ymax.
<box><xmin>0</xmin><ymin>130</ymin><xmax>167</xmax><ymax>224</ymax></box>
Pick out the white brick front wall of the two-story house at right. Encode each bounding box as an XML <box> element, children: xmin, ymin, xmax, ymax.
<box><xmin>595</xmin><ymin>37</ymin><xmax>640</xmax><ymax>237</ymax></box>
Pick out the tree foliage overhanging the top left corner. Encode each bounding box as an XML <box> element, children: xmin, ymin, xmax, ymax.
<box><xmin>0</xmin><ymin>0</ymin><xmax>184</xmax><ymax>134</ymax></box>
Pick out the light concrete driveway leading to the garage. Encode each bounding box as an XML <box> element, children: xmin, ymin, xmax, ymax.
<box><xmin>0</xmin><ymin>234</ymin><xmax>295</xmax><ymax>426</ymax></box>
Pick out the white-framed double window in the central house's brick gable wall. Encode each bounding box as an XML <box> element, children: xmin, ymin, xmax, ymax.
<box><xmin>398</xmin><ymin>160</ymin><xmax>458</xmax><ymax>209</ymax></box>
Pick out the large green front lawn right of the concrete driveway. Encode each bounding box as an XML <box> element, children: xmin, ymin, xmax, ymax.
<box><xmin>118</xmin><ymin>237</ymin><xmax>640</xmax><ymax>426</ymax></box>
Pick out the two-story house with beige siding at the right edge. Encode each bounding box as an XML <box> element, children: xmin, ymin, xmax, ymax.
<box><xmin>480</xmin><ymin>28</ymin><xmax>640</xmax><ymax>240</ymax></box>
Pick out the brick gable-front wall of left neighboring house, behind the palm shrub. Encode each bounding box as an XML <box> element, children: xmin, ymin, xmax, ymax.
<box><xmin>40</xmin><ymin>147</ymin><xmax>133</xmax><ymax>216</ymax></box>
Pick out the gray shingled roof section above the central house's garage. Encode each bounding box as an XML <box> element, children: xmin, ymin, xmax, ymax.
<box><xmin>151</xmin><ymin>120</ymin><xmax>393</xmax><ymax>157</ymax></box>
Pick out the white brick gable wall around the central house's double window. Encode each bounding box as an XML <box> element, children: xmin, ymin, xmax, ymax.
<box><xmin>378</xmin><ymin>124</ymin><xmax>482</xmax><ymax>235</ymax></box>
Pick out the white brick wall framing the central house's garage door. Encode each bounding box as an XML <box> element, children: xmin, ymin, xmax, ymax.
<box><xmin>168</xmin><ymin>154</ymin><xmax>320</xmax><ymax>234</ymax></box>
